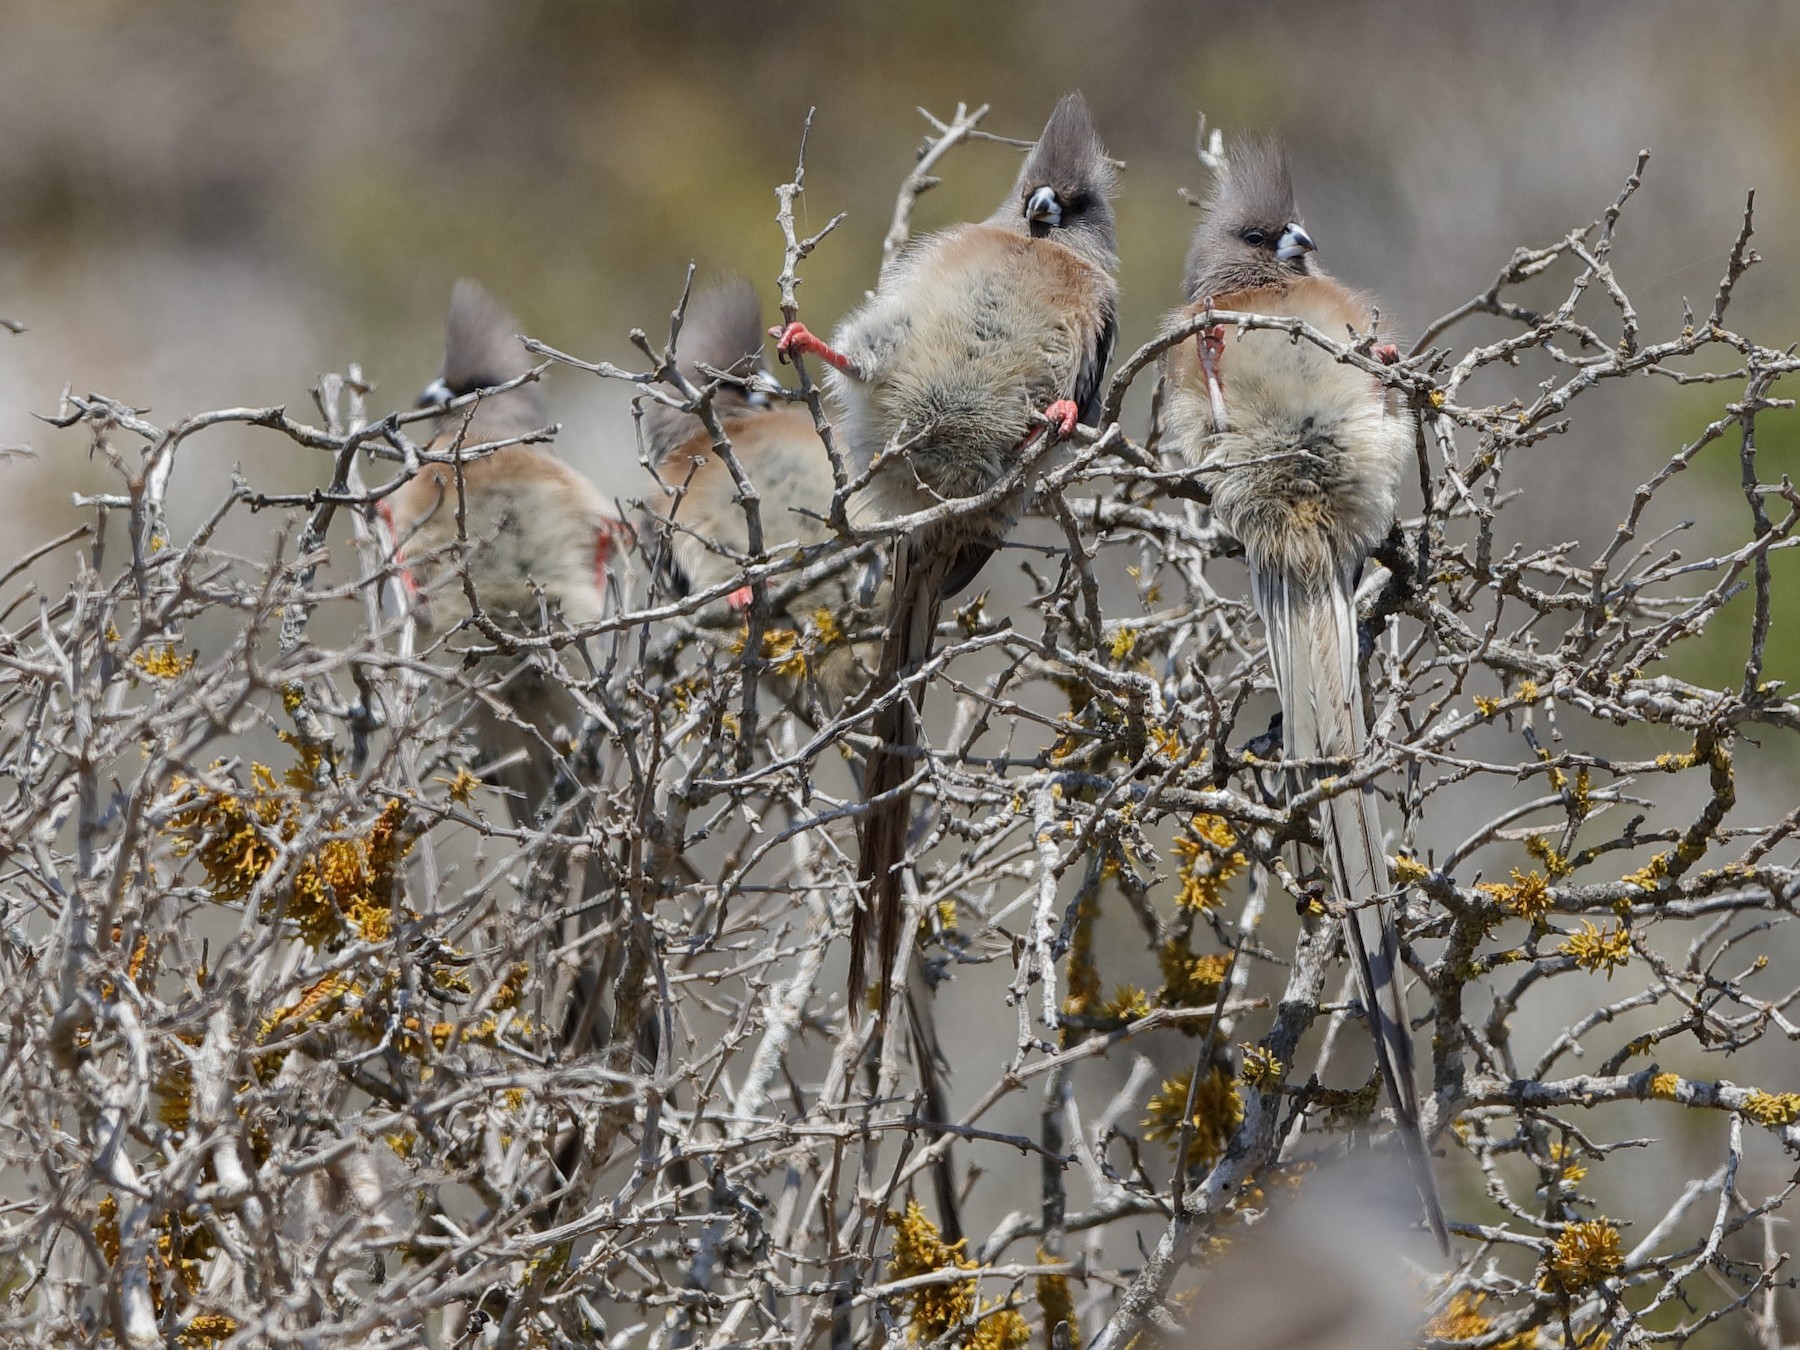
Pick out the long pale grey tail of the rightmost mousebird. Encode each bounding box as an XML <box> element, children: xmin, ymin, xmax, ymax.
<box><xmin>1253</xmin><ymin>569</ymin><xmax>1449</xmax><ymax>1251</ymax></box>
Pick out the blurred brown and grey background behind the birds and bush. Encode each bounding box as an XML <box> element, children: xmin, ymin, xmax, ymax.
<box><xmin>0</xmin><ymin>0</ymin><xmax>1800</xmax><ymax>1332</ymax></box>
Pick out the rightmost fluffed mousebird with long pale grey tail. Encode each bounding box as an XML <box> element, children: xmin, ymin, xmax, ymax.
<box><xmin>1165</xmin><ymin>142</ymin><xmax>1447</xmax><ymax>1244</ymax></box>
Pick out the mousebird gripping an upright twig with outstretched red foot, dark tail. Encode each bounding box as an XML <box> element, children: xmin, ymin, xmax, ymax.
<box><xmin>770</xmin><ymin>94</ymin><xmax>1118</xmax><ymax>1013</ymax></box>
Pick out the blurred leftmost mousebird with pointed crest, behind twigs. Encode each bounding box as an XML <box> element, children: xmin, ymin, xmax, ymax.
<box><xmin>378</xmin><ymin>281</ymin><xmax>630</xmax><ymax>826</ymax></box>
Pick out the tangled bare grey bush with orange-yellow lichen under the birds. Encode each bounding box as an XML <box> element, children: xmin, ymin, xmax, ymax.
<box><xmin>0</xmin><ymin>106</ymin><xmax>1800</xmax><ymax>1350</ymax></box>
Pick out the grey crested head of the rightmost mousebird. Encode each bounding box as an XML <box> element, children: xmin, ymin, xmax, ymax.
<box><xmin>1186</xmin><ymin>140</ymin><xmax>1314</xmax><ymax>302</ymax></box>
